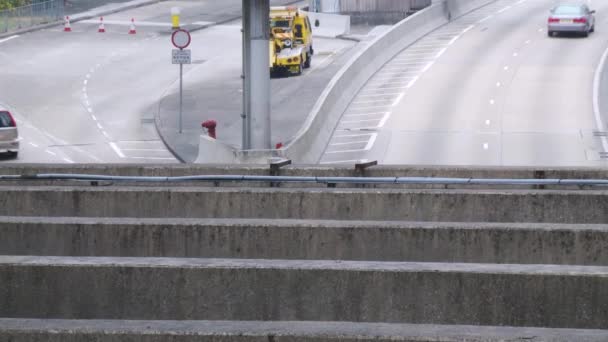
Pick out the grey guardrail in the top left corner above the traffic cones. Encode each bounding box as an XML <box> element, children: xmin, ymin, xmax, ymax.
<box><xmin>0</xmin><ymin>0</ymin><xmax>65</xmax><ymax>33</ymax></box>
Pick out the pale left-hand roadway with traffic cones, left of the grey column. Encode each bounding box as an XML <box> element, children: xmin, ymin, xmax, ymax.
<box><xmin>0</xmin><ymin>0</ymin><xmax>312</xmax><ymax>164</ymax></box>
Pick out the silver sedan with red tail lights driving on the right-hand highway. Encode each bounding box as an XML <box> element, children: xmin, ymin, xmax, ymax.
<box><xmin>547</xmin><ymin>4</ymin><xmax>595</xmax><ymax>37</ymax></box>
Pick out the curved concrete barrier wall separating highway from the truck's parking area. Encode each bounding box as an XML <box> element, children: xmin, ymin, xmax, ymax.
<box><xmin>196</xmin><ymin>0</ymin><xmax>495</xmax><ymax>164</ymax></box>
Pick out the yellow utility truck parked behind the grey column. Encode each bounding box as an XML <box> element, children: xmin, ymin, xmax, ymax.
<box><xmin>269</xmin><ymin>6</ymin><xmax>314</xmax><ymax>76</ymax></box>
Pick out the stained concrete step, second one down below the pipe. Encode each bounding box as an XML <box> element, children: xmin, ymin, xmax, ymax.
<box><xmin>0</xmin><ymin>217</ymin><xmax>608</xmax><ymax>265</ymax></box>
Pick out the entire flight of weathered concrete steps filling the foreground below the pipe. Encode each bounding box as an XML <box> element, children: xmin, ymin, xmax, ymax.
<box><xmin>0</xmin><ymin>165</ymin><xmax>608</xmax><ymax>342</ymax></box>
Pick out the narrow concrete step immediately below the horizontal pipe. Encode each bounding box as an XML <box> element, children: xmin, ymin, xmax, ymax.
<box><xmin>0</xmin><ymin>186</ymin><xmax>608</xmax><ymax>223</ymax></box>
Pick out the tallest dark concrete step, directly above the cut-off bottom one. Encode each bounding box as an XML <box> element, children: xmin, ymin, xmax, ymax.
<box><xmin>0</xmin><ymin>256</ymin><xmax>608</xmax><ymax>329</ymax></box>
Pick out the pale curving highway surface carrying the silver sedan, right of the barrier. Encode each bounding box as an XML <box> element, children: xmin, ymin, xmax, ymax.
<box><xmin>321</xmin><ymin>0</ymin><xmax>608</xmax><ymax>166</ymax></box>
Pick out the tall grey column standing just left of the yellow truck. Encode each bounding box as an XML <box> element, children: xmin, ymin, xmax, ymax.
<box><xmin>242</xmin><ymin>0</ymin><xmax>271</xmax><ymax>150</ymax></box>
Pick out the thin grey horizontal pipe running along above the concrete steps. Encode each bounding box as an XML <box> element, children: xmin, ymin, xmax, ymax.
<box><xmin>0</xmin><ymin>173</ymin><xmax>608</xmax><ymax>186</ymax></box>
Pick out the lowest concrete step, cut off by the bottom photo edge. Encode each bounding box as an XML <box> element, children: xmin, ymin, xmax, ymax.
<box><xmin>0</xmin><ymin>319</ymin><xmax>608</xmax><ymax>342</ymax></box>
